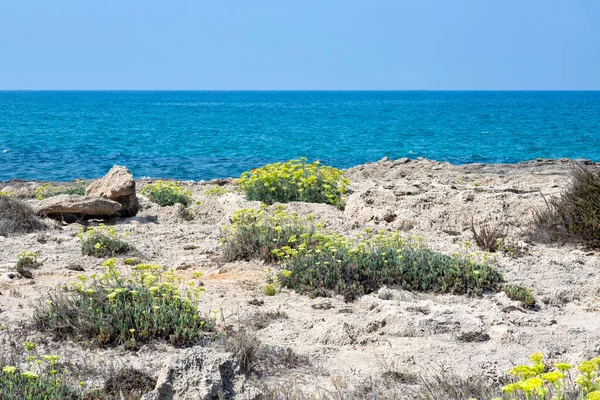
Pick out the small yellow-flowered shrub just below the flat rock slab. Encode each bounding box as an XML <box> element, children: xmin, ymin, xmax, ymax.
<box><xmin>77</xmin><ymin>224</ymin><xmax>135</xmax><ymax>257</ymax></box>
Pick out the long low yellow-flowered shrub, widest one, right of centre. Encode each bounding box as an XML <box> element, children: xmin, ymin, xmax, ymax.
<box><xmin>276</xmin><ymin>231</ymin><xmax>503</xmax><ymax>301</ymax></box>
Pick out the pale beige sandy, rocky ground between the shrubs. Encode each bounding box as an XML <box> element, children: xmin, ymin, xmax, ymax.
<box><xmin>0</xmin><ymin>159</ymin><xmax>600</xmax><ymax>394</ymax></box>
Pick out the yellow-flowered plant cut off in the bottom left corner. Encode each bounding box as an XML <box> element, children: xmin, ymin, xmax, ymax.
<box><xmin>0</xmin><ymin>342</ymin><xmax>100</xmax><ymax>400</ymax></box>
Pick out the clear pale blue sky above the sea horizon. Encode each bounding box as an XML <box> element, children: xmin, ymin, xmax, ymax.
<box><xmin>0</xmin><ymin>0</ymin><xmax>600</xmax><ymax>90</ymax></box>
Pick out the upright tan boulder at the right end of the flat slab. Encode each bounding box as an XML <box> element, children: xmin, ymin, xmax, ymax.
<box><xmin>85</xmin><ymin>165</ymin><xmax>139</xmax><ymax>217</ymax></box>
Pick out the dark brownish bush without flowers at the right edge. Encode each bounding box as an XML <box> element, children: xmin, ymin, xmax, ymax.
<box><xmin>533</xmin><ymin>164</ymin><xmax>600</xmax><ymax>247</ymax></box>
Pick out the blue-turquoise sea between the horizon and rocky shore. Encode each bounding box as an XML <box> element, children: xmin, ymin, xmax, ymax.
<box><xmin>0</xmin><ymin>91</ymin><xmax>600</xmax><ymax>180</ymax></box>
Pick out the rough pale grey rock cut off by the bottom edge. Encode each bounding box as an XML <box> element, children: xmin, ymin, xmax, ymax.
<box><xmin>142</xmin><ymin>346</ymin><xmax>237</xmax><ymax>400</ymax></box>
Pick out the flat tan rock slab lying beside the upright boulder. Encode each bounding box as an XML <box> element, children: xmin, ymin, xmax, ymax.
<box><xmin>33</xmin><ymin>194</ymin><xmax>121</xmax><ymax>217</ymax></box>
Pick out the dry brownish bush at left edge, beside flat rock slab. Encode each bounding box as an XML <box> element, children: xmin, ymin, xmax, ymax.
<box><xmin>0</xmin><ymin>196</ymin><xmax>45</xmax><ymax>236</ymax></box>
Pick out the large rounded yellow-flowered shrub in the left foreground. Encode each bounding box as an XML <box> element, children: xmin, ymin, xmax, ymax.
<box><xmin>34</xmin><ymin>258</ymin><xmax>213</xmax><ymax>348</ymax></box>
